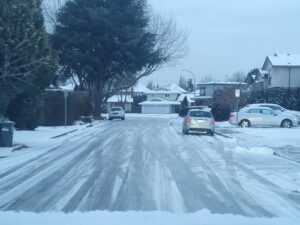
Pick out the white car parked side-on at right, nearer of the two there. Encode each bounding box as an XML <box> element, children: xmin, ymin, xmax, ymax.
<box><xmin>229</xmin><ymin>106</ymin><xmax>298</xmax><ymax>128</ymax></box>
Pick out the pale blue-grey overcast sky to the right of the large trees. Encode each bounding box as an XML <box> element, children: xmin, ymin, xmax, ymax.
<box><xmin>142</xmin><ymin>0</ymin><xmax>300</xmax><ymax>84</ymax></box>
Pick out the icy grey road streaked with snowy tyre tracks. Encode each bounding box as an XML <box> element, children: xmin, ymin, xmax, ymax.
<box><xmin>0</xmin><ymin>117</ymin><xmax>300</xmax><ymax>217</ymax></box>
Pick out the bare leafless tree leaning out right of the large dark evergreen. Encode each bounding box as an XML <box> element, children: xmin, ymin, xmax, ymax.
<box><xmin>104</xmin><ymin>15</ymin><xmax>188</xmax><ymax>102</ymax></box>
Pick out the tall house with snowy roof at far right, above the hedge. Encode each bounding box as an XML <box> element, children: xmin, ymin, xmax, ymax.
<box><xmin>260</xmin><ymin>54</ymin><xmax>300</xmax><ymax>89</ymax></box>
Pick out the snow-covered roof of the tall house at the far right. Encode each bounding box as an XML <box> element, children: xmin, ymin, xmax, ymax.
<box><xmin>267</xmin><ymin>54</ymin><xmax>300</xmax><ymax>66</ymax></box>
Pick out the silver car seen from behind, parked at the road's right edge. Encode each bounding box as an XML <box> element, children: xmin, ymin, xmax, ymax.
<box><xmin>182</xmin><ymin>109</ymin><xmax>215</xmax><ymax>136</ymax></box>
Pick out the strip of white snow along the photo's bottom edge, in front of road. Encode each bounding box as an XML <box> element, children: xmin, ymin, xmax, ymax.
<box><xmin>0</xmin><ymin>210</ymin><xmax>299</xmax><ymax>225</ymax></box>
